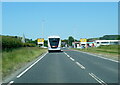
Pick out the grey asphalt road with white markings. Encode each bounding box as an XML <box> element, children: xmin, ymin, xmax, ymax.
<box><xmin>4</xmin><ymin>48</ymin><xmax>118</xmax><ymax>85</ymax></box>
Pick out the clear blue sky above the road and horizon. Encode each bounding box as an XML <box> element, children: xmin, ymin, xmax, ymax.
<box><xmin>2</xmin><ymin>2</ymin><xmax>118</xmax><ymax>39</ymax></box>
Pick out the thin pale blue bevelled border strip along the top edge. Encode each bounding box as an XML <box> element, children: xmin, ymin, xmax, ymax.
<box><xmin>1</xmin><ymin>0</ymin><xmax>120</xmax><ymax>2</ymax></box>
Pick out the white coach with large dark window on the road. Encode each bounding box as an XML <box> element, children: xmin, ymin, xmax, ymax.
<box><xmin>48</xmin><ymin>36</ymin><xmax>61</xmax><ymax>52</ymax></box>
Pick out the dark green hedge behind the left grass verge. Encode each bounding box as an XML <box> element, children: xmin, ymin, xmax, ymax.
<box><xmin>1</xmin><ymin>36</ymin><xmax>36</xmax><ymax>51</ymax></box>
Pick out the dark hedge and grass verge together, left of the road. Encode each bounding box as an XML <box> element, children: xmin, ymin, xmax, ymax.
<box><xmin>0</xmin><ymin>35</ymin><xmax>47</xmax><ymax>78</ymax></box>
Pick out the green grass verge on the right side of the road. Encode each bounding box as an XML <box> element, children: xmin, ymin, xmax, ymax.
<box><xmin>72</xmin><ymin>45</ymin><xmax>120</xmax><ymax>60</ymax></box>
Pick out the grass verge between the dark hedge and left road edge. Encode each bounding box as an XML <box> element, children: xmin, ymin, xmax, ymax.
<box><xmin>2</xmin><ymin>47</ymin><xmax>47</xmax><ymax>79</ymax></box>
